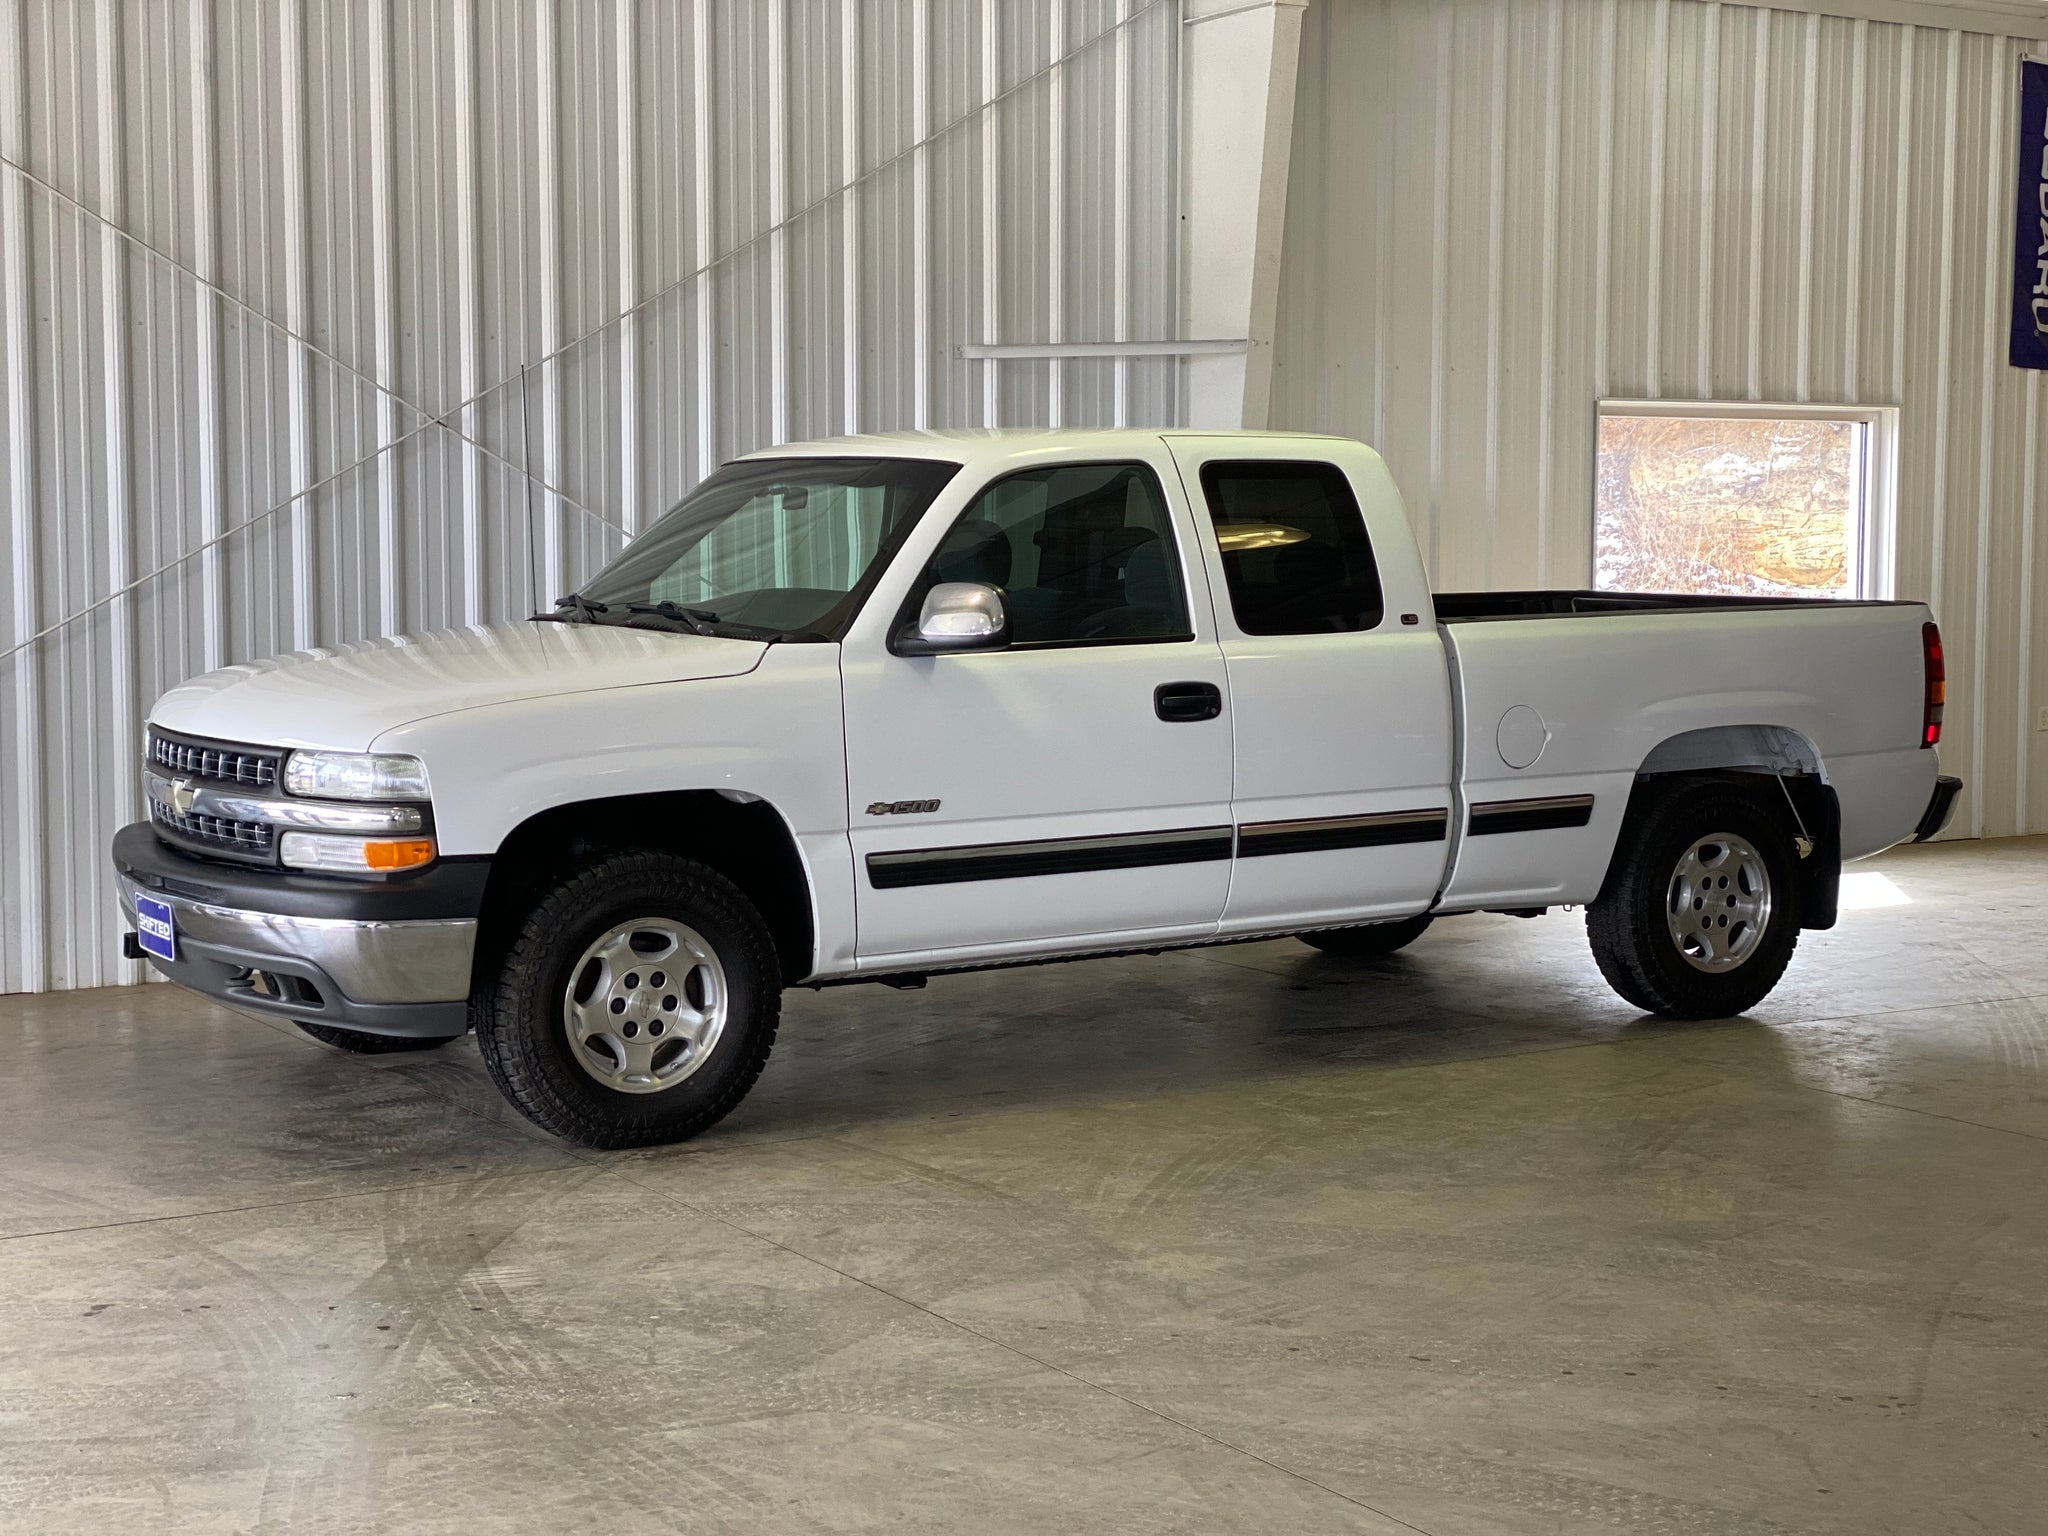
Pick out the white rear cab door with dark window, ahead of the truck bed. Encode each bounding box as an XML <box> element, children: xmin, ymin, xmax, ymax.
<box><xmin>1167</xmin><ymin>434</ymin><xmax>1452</xmax><ymax>934</ymax></box>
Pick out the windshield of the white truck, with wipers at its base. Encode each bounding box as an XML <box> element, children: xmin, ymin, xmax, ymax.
<box><xmin>559</xmin><ymin>459</ymin><xmax>961</xmax><ymax>641</ymax></box>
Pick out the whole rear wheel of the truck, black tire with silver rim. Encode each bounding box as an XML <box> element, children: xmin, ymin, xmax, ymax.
<box><xmin>1585</xmin><ymin>780</ymin><xmax>1800</xmax><ymax>1018</ymax></box>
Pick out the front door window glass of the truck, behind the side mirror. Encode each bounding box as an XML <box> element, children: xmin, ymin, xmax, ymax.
<box><xmin>909</xmin><ymin>465</ymin><xmax>1192</xmax><ymax>645</ymax></box>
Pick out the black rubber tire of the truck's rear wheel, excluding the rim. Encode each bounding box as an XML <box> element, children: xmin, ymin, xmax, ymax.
<box><xmin>1585</xmin><ymin>778</ymin><xmax>1800</xmax><ymax>1018</ymax></box>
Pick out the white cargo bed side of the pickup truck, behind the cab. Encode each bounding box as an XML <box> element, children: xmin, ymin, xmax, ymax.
<box><xmin>1436</xmin><ymin>592</ymin><xmax>1935</xmax><ymax>921</ymax></box>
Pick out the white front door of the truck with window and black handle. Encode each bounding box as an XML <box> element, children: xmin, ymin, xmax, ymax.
<box><xmin>842</xmin><ymin>444</ymin><xmax>1233</xmax><ymax>971</ymax></box>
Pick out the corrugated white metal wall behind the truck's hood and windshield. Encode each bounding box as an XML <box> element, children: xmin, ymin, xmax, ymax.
<box><xmin>0</xmin><ymin>0</ymin><xmax>1180</xmax><ymax>991</ymax></box>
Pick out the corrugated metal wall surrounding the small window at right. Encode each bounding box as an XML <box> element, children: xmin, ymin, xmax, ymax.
<box><xmin>1274</xmin><ymin>0</ymin><xmax>2048</xmax><ymax>836</ymax></box>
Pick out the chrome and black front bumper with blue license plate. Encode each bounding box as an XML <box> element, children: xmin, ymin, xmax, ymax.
<box><xmin>113</xmin><ymin>821</ymin><xmax>489</xmax><ymax>1036</ymax></box>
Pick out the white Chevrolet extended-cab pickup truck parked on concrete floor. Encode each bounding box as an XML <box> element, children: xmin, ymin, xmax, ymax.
<box><xmin>113</xmin><ymin>432</ymin><xmax>1958</xmax><ymax>1147</ymax></box>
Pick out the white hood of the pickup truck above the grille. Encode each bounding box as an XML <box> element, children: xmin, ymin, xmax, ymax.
<box><xmin>150</xmin><ymin>623</ymin><xmax>768</xmax><ymax>752</ymax></box>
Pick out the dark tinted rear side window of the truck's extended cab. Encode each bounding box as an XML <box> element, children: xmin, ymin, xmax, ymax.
<box><xmin>1202</xmin><ymin>461</ymin><xmax>1386</xmax><ymax>635</ymax></box>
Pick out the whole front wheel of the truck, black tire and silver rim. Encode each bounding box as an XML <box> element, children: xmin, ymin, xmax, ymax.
<box><xmin>475</xmin><ymin>850</ymin><xmax>782</xmax><ymax>1147</ymax></box>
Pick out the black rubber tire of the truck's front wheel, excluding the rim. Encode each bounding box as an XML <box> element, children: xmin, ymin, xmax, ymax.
<box><xmin>471</xmin><ymin>850</ymin><xmax>782</xmax><ymax>1147</ymax></box>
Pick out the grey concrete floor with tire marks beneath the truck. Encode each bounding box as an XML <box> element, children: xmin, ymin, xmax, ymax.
<box><xmin>0</xmin><ymin>840</ymin><xmax>2048</xmax><ymax>1536</ymax></box>
